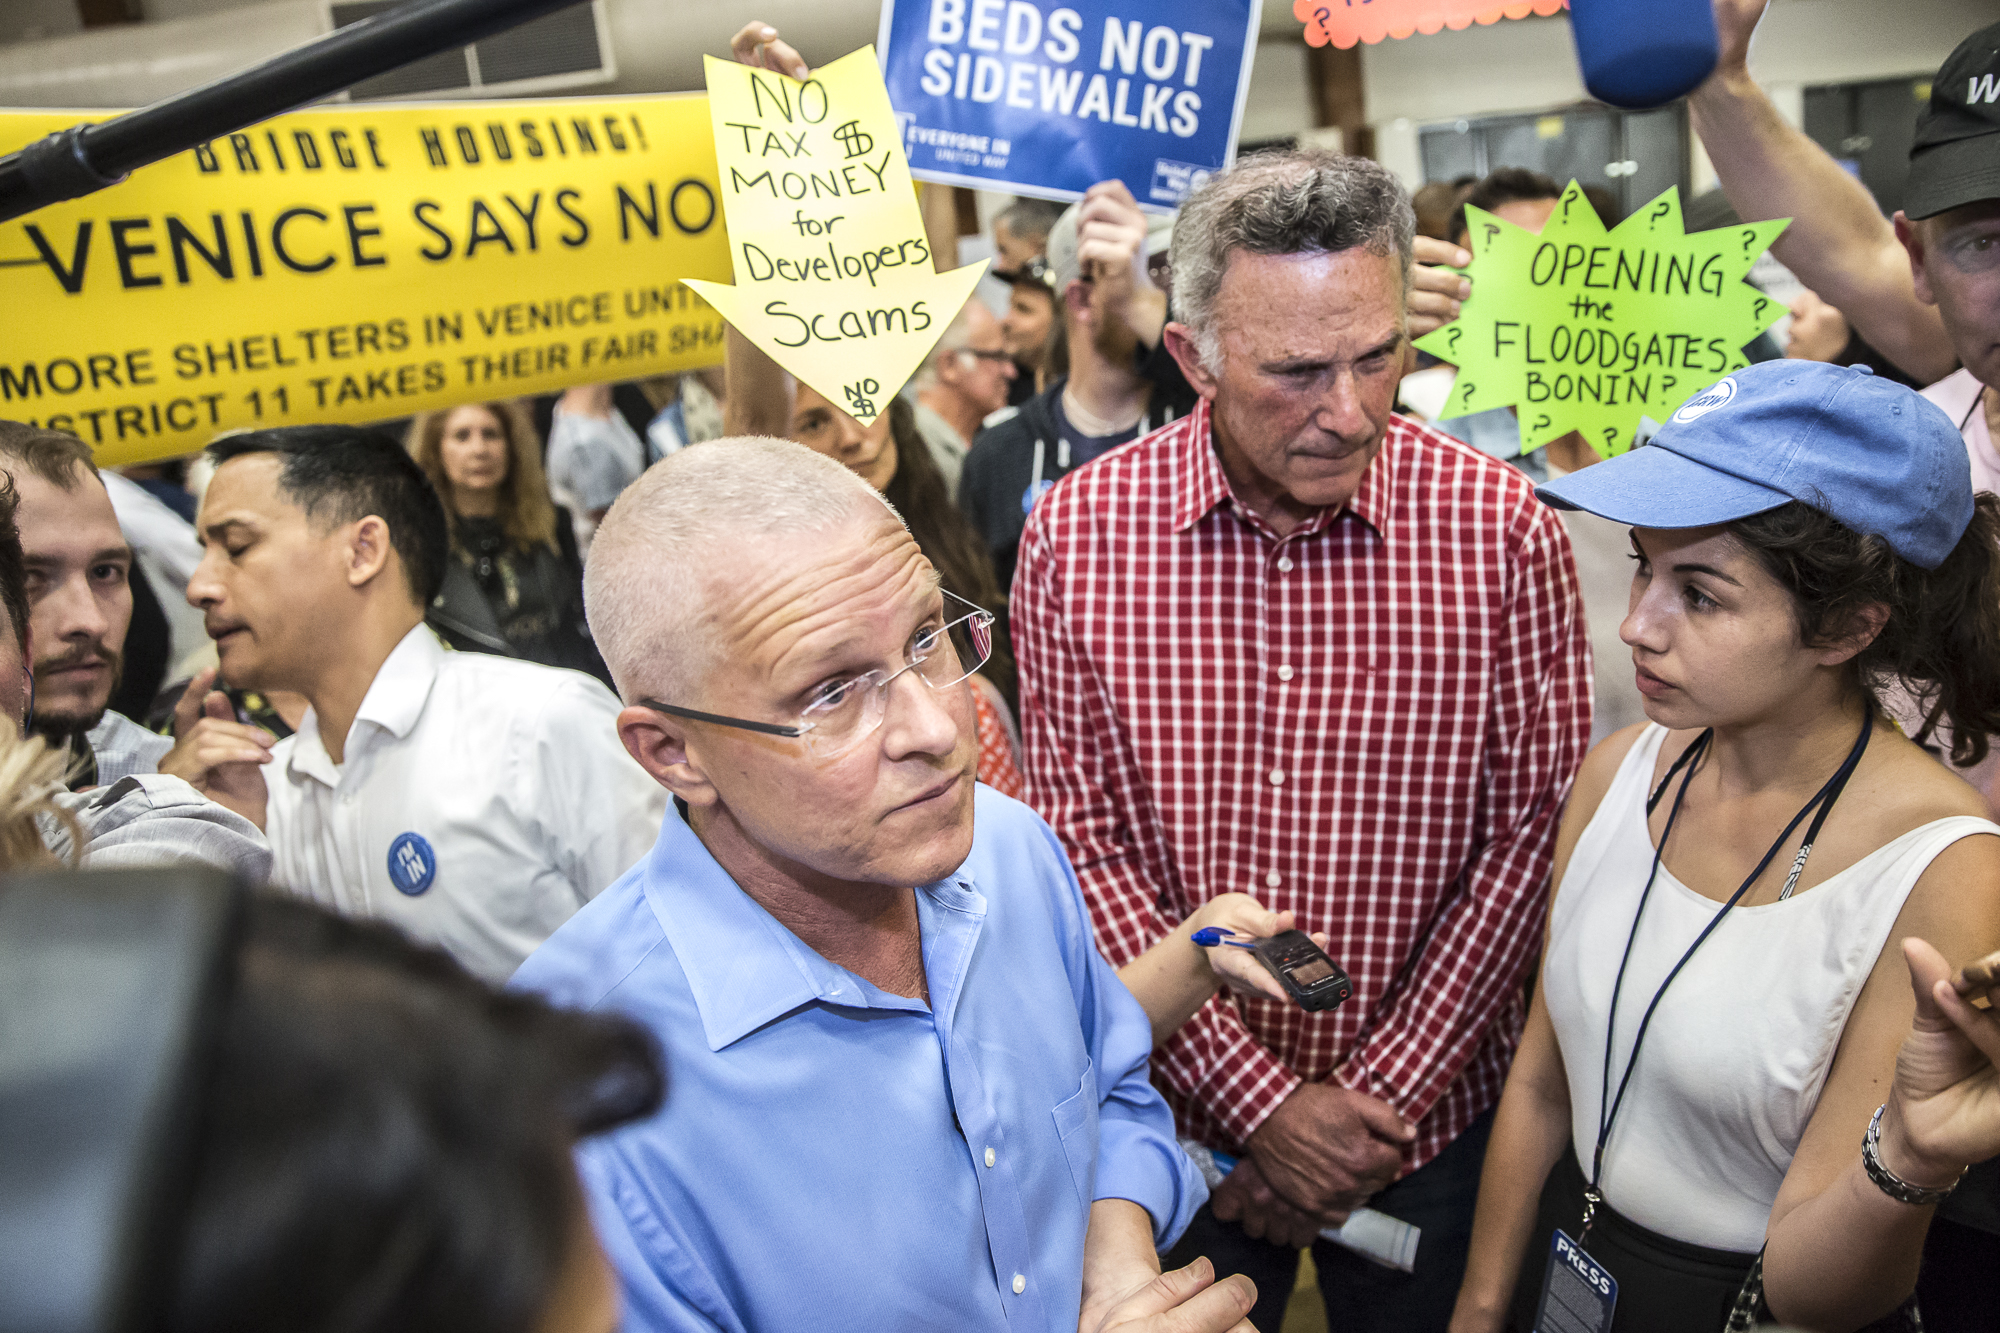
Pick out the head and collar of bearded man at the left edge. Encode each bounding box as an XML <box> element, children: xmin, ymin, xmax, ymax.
<box><xmin>0</xmin><ymin>420</ymin><xmax>174</xmax><ymax>789</ymax></box>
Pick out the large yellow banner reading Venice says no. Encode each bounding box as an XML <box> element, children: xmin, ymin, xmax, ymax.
<box><xmin>0</xmin><ymin>96</ymin><xmax>728</xmax><ymax>464</ymax></box>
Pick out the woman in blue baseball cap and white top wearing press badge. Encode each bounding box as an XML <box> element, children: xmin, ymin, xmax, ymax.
<box><xmin>1452</xmin><ymin>360</ymin><xmax>2000</xmax><ymax>1333</ymax></box>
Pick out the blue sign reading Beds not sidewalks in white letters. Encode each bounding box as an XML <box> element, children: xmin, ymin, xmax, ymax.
<box><xmin>876</xmin><ymin>0</ymin><xmax>1260</xmax><ymax>212</ymax></box>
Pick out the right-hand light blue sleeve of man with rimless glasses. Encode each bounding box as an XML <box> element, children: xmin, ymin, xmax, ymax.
<box><xmin>1036</xmin><ymin>821</ymin><xmax>1208</xmax><ymax>1251</ymax></box>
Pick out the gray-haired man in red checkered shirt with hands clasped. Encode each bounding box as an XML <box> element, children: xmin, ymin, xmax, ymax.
<box><xmin>1012</xmin><ymin>154</ymin><xmax>1590</xmax><ymax>1333</ymax></box>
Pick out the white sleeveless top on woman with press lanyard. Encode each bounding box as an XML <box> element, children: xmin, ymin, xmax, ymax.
<box><xmin>1542</xmin><ymin>727</ymin><xmax>2000</xmax><ymax>1253</ymax></box>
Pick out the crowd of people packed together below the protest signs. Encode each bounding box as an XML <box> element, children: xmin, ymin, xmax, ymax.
<box><xmin>0</xmin><ymin>0</ymin><xmax>2000</xmax><ymax>1333</ymax></box>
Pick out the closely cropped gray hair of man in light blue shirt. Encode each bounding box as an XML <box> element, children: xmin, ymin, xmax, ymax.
<box><xmin>584</xmin><ymin>436</ymin><xmax>902</xmax><ymax>703</ymax></box>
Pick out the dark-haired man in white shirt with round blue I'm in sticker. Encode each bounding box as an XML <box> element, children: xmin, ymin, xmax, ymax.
<box><xmin>168</xmin><ymin>426</ymin><xmax>666</xmax><ymax>981</ymax></box>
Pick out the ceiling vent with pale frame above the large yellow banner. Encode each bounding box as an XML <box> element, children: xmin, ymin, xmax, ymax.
<box><xmin>326</xmin><ymin>0</ymin><xmax>618</xmax><ymax>102</ymax></box>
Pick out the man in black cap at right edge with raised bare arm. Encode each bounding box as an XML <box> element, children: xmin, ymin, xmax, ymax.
<box><xmin>1688</xmin><ymin>0</ymin><xmax>2000</xmax><ymax>1333</ymax></box>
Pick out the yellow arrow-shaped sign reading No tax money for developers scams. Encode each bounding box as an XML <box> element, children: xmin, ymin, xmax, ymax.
<box><xmin>688</xmin><ymin>46</ymin><xmax>986</xmax><ymax>424</ymax></box>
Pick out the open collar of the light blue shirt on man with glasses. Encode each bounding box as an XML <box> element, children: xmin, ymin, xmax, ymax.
<box><xmin>642</xmin><ymin>809</ymin><xmax>986</xmax><ymax>1051</ymax></box>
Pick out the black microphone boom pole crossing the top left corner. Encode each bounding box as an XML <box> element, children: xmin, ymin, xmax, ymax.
<box><xmin>0</xmin><ymin>0</ymin><xmax>580</xmax><ymax>222</ymax></box>
